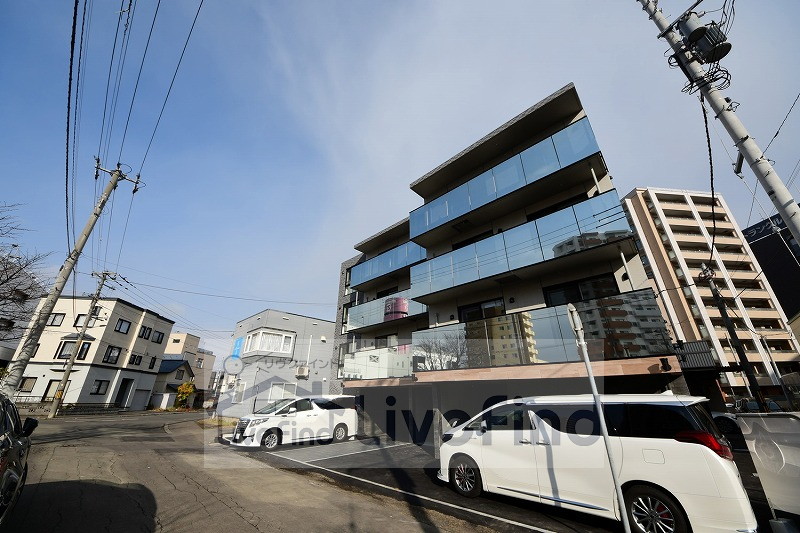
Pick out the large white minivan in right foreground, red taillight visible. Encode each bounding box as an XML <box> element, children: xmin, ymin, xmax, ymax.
<box><xmin>439</xmin><ymin>394</ymin><xmax>757</xmax><ymax>533</ymax></box>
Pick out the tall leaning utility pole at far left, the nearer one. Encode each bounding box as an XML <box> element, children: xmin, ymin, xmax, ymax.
<box><xmin>0</xmin><ymin>158</ymin><xmax>139</xmax><ymax>398</ymax></box>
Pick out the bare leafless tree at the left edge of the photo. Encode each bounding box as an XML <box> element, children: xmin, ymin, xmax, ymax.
<box><xmin>0</xmin><ymin>203</ymin><xmax>49</xmax><ymax>358</ymax></box>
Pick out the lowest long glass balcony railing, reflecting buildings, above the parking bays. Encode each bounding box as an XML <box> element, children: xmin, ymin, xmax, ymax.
<box><xmin>411</xmin><ymin>289</ymin><xmax>673</xmax><ymax>372</ymax></box>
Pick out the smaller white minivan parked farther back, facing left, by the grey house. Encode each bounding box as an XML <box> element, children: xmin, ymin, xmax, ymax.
<box><xmin>230</xmin><ymin>396</ymin><xmax>358</xmax><ymax>450</ymax></box>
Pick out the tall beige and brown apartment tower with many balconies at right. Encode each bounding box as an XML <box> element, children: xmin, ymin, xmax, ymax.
<box><xmin>624</xmin><ymin>188</ymin><xmax>800</xmax><ymax>395</ymax></box>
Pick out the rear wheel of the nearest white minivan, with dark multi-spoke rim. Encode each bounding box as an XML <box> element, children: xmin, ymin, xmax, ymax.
<box><xmin>625</xmin><ymin>485</ymin><xmax>691</xmax><ymax>533</ymax></box>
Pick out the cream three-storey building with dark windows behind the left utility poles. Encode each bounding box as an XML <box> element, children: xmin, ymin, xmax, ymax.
<box><xmin>9</xmin><ymin>296</ymin><xmax>174</xmax><ymax>410</ymax></box>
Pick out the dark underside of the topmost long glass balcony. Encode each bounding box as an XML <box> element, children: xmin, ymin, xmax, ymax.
<box><xmin>411</xmin><ymin>152</ymin><xmax>608</xmax><ymax>248</ymax></box>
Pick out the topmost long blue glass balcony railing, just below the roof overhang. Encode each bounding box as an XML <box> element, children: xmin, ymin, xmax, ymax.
<box><xmin>409</xmin><ymin>118</ymin><xmax>600</xmax><ymax>239</ymax></box>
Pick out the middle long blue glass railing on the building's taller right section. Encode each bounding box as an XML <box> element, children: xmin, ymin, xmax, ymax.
<box><xmin>410</xmin><ymin>190</ymin><xmax>632</xmax><ymax>298</ymax></box>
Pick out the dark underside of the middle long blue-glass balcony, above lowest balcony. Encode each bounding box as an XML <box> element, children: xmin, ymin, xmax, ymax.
<box><xmin>413</xmin><ymin>236</ymin><xmax>638</xmax><ymax>305</ymax></box>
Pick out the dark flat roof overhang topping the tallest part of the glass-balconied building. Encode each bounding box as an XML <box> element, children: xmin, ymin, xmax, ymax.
<box><xmin>410</xmin><ymin>83</ymin><xmax>583</xmax><ymax>199</ymax></box>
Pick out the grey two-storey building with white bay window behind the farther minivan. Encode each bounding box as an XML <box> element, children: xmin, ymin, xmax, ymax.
<box><xmin>217</xmin><ymin>309</ymin><xmax>334</xmax><ymax>417</ymax></box>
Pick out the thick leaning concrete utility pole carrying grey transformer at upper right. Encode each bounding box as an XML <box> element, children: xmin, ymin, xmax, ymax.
<box><xmin>637</xmin><ymin>0</ymin><xmax>800</xmax><ymax>249</ymax></box>
